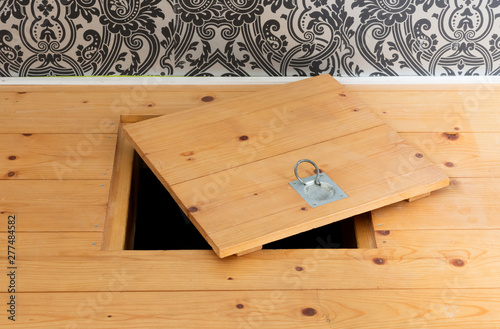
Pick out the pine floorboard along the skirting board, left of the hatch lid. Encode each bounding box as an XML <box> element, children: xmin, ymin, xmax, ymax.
<box><xmin>0</xmin><ymin>85</ymin><xmax>265</xmax><ymax>134</ymax></box>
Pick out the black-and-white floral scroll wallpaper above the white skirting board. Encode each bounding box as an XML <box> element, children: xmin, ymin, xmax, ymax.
<box><xmin>0</xmin><ymin>0</ymin><xmax>500</xmax><ymax>77</ymax></box>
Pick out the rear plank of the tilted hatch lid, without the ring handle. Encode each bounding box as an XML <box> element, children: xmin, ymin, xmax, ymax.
<box><xmin>124</xmin><ymin>78</ymin><xmax>374</xmax><ymax>185</ymax></box>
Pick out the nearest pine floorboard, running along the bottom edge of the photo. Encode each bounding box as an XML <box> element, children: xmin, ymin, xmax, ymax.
<box><xmin>0</xmin><ymin>285</ymin><xmax>500</xmax><ymax>329</ymax></box>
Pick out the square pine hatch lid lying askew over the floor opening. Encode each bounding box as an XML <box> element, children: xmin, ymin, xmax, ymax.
<box><xmin>124</xmin><ymin>75</ymin><xmax>449</xmax><ymax>257</ymax></box>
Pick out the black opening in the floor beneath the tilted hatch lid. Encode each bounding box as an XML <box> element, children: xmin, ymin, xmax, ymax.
<box><xmin>132</xmin><ymin>155</ymin><xmax>356</xmax><ymax>250</ymax></box>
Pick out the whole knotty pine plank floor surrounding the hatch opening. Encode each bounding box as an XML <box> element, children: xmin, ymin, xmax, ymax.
<box><xmin>0</xmin><ymin>84</ymin><xmax>500</xmax><ymax>329</ymax></box>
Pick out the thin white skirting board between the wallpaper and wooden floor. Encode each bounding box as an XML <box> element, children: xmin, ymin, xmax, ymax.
<box><xmin>0</xmin><ymin>76</ymin><xmax>500</xmax><ymax>86</ymax></box>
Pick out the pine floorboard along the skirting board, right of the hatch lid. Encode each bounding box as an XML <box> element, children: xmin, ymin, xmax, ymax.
<box><xmin>347</xmin><ymin>84</ymin><xmax>500</xmax><ymax>133</ymax></box>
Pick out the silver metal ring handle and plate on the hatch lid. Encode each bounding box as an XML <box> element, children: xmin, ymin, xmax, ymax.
<box><xmin>289</xmin><ymin>159</ymin><xmax>348</xmax><ymax>208</ymax></box>
